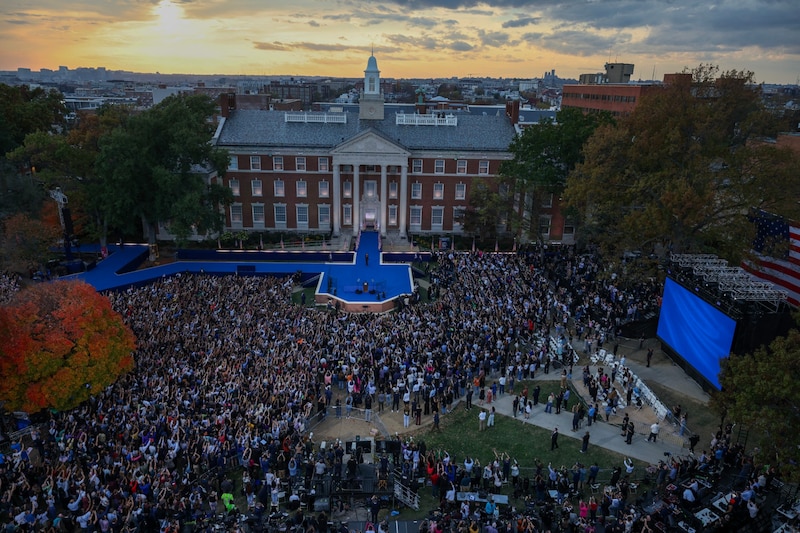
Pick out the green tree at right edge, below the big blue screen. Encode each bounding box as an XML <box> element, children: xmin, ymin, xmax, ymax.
<box><xmin>710</xmin><ymin>329</ymin><xmax>800</xmax><ymax>482</ymax></box>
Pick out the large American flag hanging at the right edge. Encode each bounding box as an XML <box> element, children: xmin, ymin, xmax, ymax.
<box><xmin>742</xmin><ymin>211</ymin><xmax>800</xmax><ymax>307</ymax></box>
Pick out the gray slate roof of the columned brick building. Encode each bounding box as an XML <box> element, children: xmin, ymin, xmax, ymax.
<box><xmin>217</xmin><ymin>105</ymin><xmax>515</xmax><ymax>152</ymax></box>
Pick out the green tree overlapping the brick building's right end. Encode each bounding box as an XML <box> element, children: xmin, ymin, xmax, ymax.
<box><xmin>500</xmin><ymin>109</ymin><xmax>612</xmax><ymax>240</ymax></box>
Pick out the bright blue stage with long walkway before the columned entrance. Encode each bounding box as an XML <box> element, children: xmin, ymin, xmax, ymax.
<box><xmin>67</xmin><ymin>232</ymin><xmax>416</xmax><ymax>311</ymax></box>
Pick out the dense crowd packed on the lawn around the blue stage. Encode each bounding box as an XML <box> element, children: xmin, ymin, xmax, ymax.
<box><xmin>0</xmin><ymin>248</ymin><xmax>700</xmax><ymax>532</ymax></box>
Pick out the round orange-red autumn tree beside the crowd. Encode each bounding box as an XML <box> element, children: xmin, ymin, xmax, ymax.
<box><xmin>0</xmin><ymin>281</ymin><xmax>136</xmax><ymax>413</ymax></box>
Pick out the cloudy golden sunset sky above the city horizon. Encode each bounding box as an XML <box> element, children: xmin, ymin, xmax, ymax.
<box><xmin>0</xmin><ymin>0</ymin><xmax>800</xmax><ymax>84</ymax></box>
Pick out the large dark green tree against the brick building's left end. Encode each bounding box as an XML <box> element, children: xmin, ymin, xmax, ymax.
<box><xmin>93</xmin><ymin>95</ymin><xmax>232</xmax><ymax>243</ymax></box>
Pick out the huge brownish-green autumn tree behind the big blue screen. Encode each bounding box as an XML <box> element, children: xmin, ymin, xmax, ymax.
<box><xmin>564</xmin><ymin>65</ymin><xmax>800</xmax><ymax>261</ymax></box>
